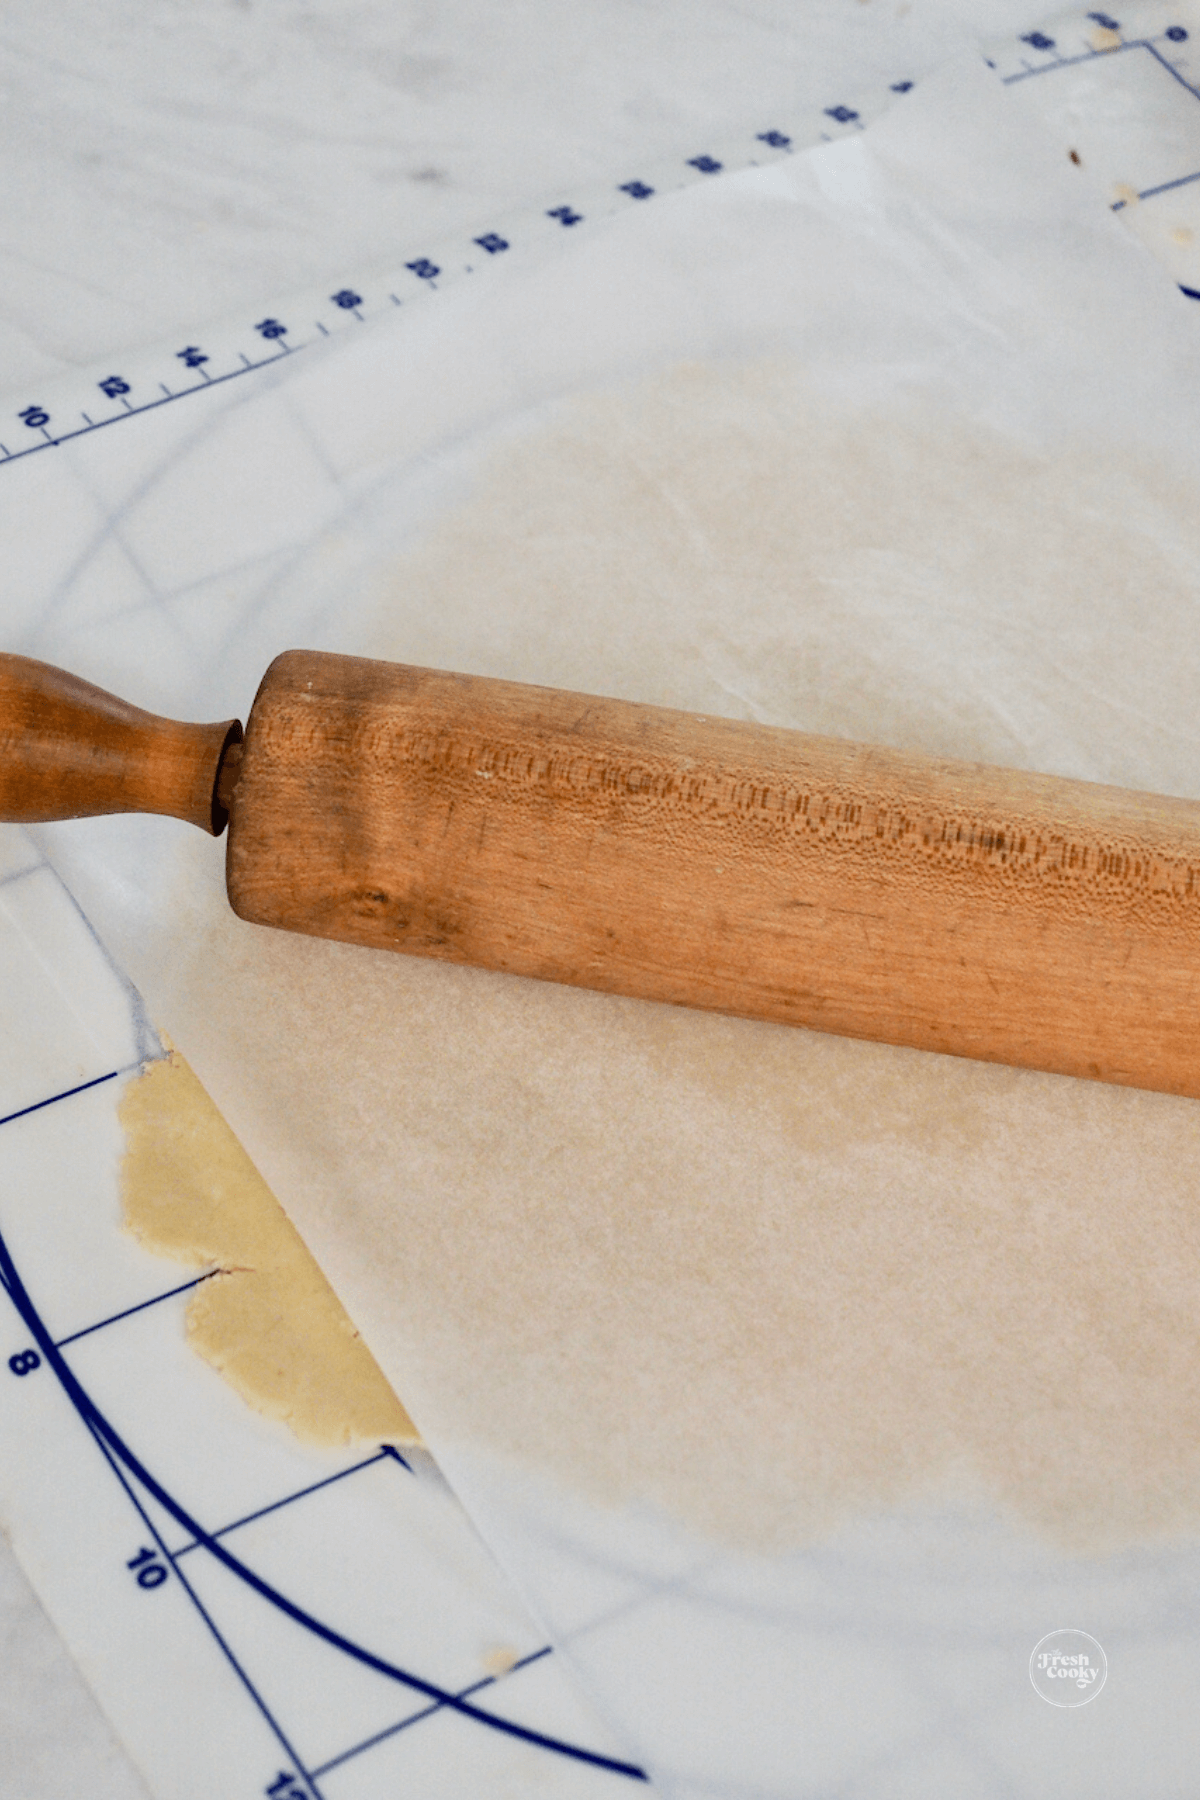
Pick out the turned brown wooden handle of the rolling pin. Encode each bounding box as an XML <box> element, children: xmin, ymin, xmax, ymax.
<box><xmin>0</xmin><ymin>653</ymin><xmax>241</xmax><ymax>835</ymax></box>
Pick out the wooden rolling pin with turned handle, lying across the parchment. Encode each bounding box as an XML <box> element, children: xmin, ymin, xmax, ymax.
<box><xmin>0</xmin><ymin>650</ymin><xmax>1200</xmax><ymax>1096</ymax></box>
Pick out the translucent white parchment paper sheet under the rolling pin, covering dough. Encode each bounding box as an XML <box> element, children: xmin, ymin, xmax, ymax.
<box><xmin>28</xmin><ymin>56</ymin><xmax>1200</xmax><ymax>1795</ymax></box>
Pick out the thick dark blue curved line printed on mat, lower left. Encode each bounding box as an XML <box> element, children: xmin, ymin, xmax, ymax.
<box><xmin>0</xmin><ymin>1235</ymin><xmax>649</xmax><ymax>1782</ymax></box>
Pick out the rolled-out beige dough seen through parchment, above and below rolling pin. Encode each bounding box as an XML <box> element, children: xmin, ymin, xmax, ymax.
<box><xmin>145</xmin><ymin>364</ymin><xmax>1200</xmax><ymax>1550</ymax></box>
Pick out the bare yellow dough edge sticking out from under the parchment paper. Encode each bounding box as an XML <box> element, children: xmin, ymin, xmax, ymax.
<box><xmin>119</xmin><ymin>1049</ymin><xmax>419</xmax><ymax>1445</ymax></box>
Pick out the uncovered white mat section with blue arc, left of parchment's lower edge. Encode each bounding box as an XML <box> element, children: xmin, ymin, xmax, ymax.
<box><xmin>0</xmin><ymin>830</ymin><xmax>644</xmax><ymax>1800</ymax></box>
